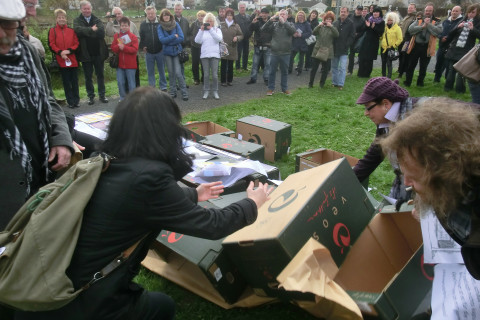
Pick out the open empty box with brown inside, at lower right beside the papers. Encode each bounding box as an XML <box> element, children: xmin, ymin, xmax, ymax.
<box><xmin>334</xmin><ymin>212</ymin><xmax>433</xmax><ymax>319</ymax></box>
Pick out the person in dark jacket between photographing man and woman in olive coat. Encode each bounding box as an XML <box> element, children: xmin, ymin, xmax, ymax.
<box><xmin>288</xmin><ymin>10</ymin><xmax>312</xmax><ymax>76</ymax></box>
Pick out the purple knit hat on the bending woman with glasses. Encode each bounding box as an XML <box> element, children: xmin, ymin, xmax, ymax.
<box><xmin>357</xmin><ymin>77</ymin><xmax>409</xmax><ymax>104</ymax></box>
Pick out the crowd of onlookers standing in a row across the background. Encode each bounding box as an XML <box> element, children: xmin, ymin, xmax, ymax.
<box><xmin>18</xmin><ymin>1</ymin><xmax>480</xmax><ymax>104</ymax></box>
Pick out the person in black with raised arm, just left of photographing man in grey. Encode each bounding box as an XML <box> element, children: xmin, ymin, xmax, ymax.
<box><xmin>247</xmin><ymin>8</ymin><xmax>272</xmax><ymax>85</ymax></box>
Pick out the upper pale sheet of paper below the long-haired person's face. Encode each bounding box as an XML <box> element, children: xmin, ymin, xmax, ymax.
<box><xmin>420</xmin><ymin>210</ymin><xmax>463</xmax><ymax>263</ymax></box>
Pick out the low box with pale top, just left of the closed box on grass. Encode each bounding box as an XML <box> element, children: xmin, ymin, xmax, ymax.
<box><xmin>200</xmin><ymin>134</ymin><xmax>265</xmax><ymax>162</ymax></box>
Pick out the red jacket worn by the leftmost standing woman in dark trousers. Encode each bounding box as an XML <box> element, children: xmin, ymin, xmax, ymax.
<box><xmin>48</xmin><ymin>24</ymin><xmax>79</xmax><ymax>68</ymax></box>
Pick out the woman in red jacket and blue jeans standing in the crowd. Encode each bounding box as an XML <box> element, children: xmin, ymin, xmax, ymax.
<box><xmin>112</xmin><ymin>17</ymin><xmax>138</xmax><ymax>101</ymax></box>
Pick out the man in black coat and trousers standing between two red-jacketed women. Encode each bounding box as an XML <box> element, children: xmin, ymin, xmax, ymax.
<box><xmin>73</xmin><ymin>1</ymin><xmax>108</xmax><ymax>105</ymax></box>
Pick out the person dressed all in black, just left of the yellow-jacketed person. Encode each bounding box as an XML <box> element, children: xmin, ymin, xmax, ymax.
<box><xmin>357</xmin><ymin>6</ymin><xmax>385</xmax><ymax>78</ymax></box>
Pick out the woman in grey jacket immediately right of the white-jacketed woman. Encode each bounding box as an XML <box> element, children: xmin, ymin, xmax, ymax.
<box><xmin>220</xmin><ymin>8</ymin><xmax>243</xmax><ymax>87</ymax></box>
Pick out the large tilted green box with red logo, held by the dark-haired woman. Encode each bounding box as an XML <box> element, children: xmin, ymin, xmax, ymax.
<box><xmin>223</xmin><ymin>159</ymin><xmax>374</xmax><ymax>296</ymax></box>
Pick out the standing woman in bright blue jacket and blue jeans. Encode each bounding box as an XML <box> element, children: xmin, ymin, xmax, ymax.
<box><xmin>158</xmin><ymin>9</ymin><xmax>188</xmax><ymax>101</ymax></box>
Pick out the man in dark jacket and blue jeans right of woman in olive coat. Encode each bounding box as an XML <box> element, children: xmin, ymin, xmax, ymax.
<box><xmin>332</xmin><ymin>7</ymin><xmax>355</xmax><ymax>90</ymax></box>
